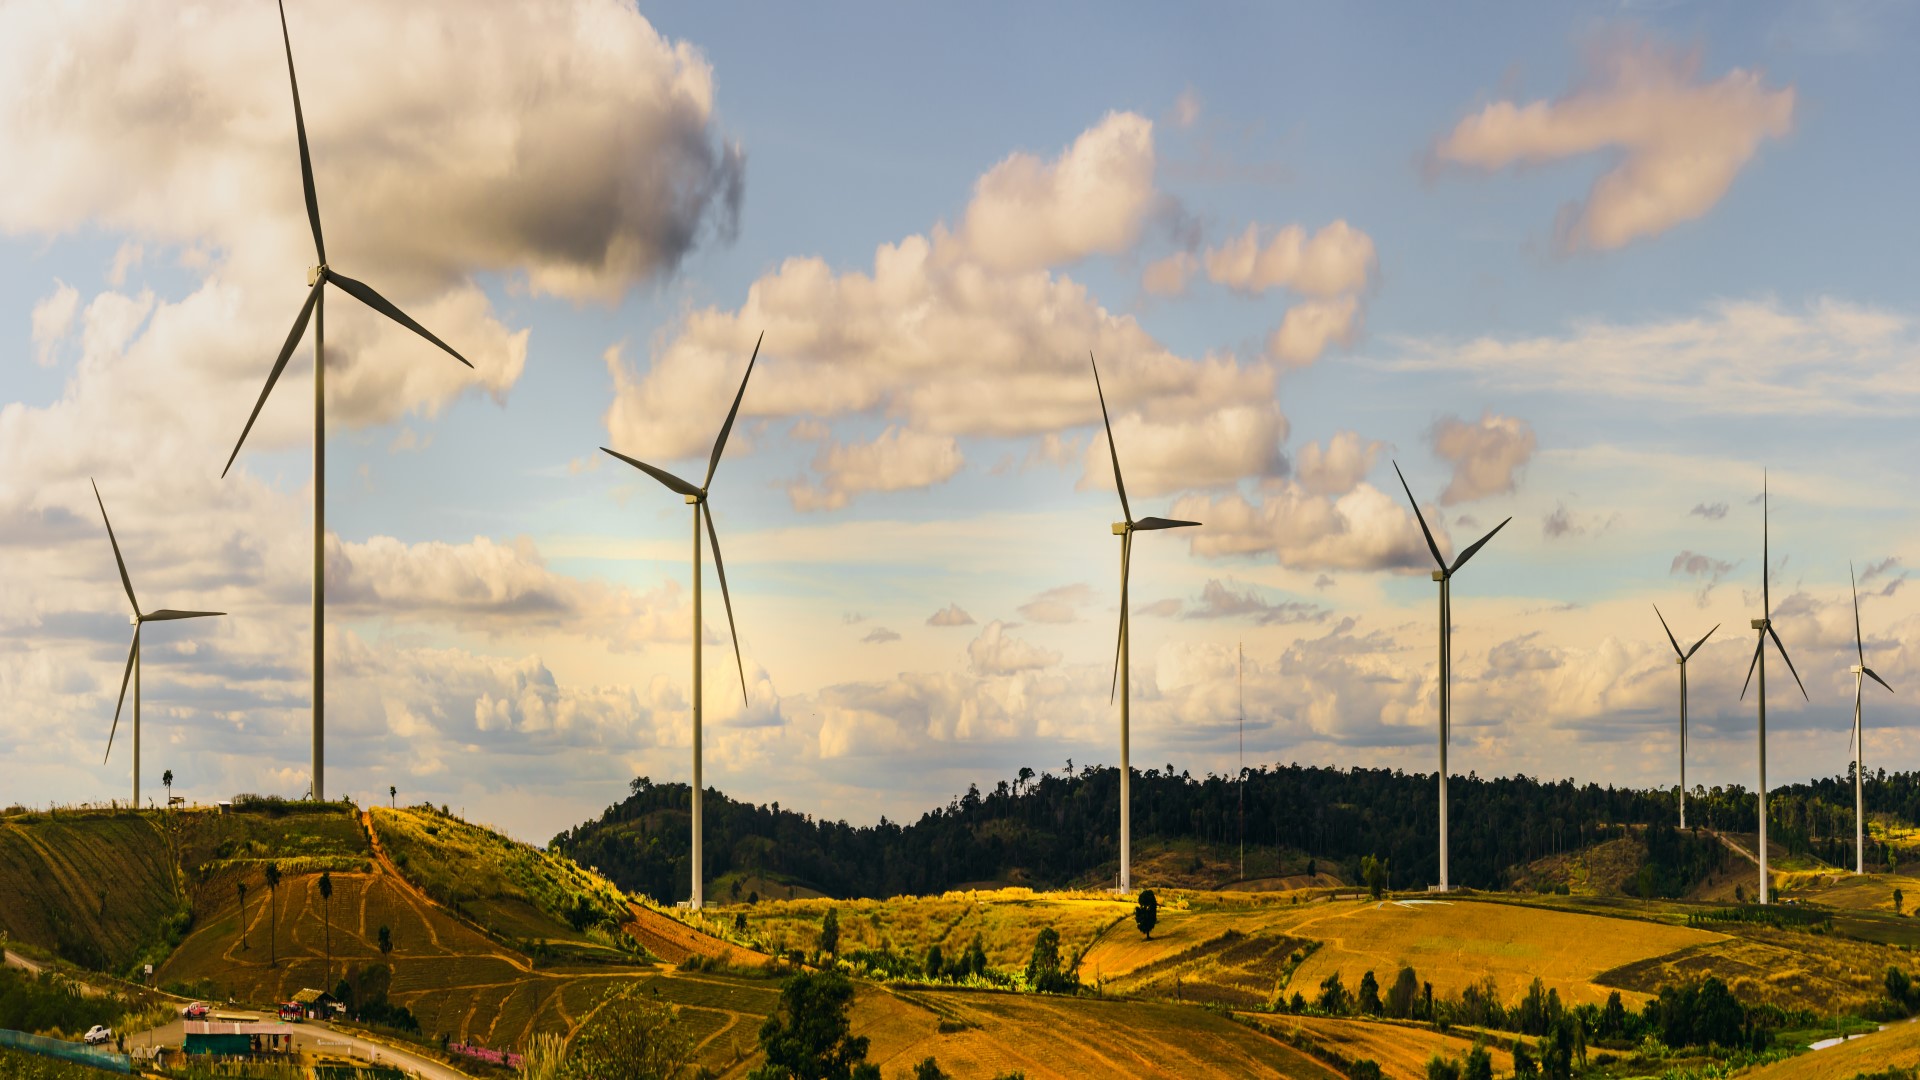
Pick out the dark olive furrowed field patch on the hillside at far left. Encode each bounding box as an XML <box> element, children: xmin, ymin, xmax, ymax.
<box><xmin>0</xmin><ymin>811</ymin><xmax>186</xmax><ymax>972</ymax></box>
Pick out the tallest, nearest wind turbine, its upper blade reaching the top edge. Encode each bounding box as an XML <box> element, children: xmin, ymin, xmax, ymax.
<box><xmin>221</xmin><ymin>0</ymin><xmax>472</xmax><ymax>799</ymax></box>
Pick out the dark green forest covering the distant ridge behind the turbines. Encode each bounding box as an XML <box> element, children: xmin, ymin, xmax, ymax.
<box><xmin>551</xmin><ymin>763</ymin><xmax>1920</xmax><ymax>901</ymax></box>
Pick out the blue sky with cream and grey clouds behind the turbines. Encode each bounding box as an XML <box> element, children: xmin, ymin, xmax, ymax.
<box><xmin>0</xmin><ymin>0</ymin><xmax>1920</xmax><ymax>842</ymax></box>
